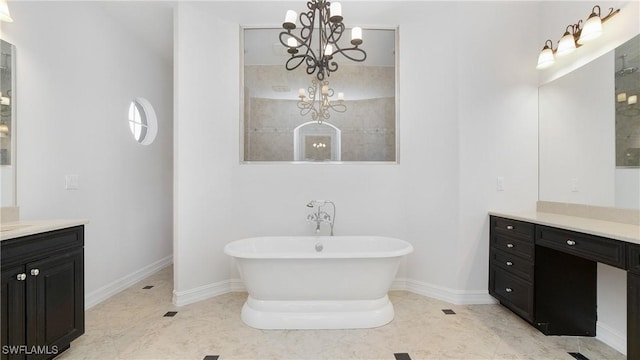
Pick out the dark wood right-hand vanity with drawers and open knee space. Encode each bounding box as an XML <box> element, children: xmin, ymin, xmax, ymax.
<box><xmin>489</xmin><ymin>215</ymin><xmax>640</xmax><ymax>360</ymax></box>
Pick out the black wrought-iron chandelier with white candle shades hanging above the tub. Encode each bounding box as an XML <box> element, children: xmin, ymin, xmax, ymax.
<box><xmin>280</xmin><ymin>0</ymin><xmax>367</xmax><ymax>81</ymax></box>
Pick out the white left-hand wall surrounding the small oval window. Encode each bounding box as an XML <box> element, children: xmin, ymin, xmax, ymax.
<box><xmin>2</xmin><ymin>1</ymin><xmax>173</xmax><ymax>306</ymax></box>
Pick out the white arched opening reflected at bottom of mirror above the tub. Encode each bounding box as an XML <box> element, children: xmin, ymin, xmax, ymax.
<box><xmin>293</xmin><ymin>121</ymin><xmax>341</xmax><ymax>161</ymax></box>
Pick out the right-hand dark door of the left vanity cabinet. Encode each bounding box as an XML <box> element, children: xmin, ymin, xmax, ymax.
<box><xmin>26</xmin><ymin>249</ymin><xmax>84</xmax><ymax>359</ymax></box>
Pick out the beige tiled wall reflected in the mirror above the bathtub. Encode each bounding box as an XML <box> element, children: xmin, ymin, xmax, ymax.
<box><xmin>244</xmin><ymin>65</ymin><xmax>396</xmax><ymax>161</ymax></box>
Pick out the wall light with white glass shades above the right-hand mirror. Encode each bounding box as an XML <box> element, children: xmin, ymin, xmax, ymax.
<box><xmin>536</xmin><ymin>5</ymin><xmax>620</xmax><ymax>70</ymax></box>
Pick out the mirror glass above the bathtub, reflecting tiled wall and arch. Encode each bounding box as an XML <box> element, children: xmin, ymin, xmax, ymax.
<box><xmin>240</xmin><ymin>28</ymin><xmax>398</xmax><ymax>163</ymax></box>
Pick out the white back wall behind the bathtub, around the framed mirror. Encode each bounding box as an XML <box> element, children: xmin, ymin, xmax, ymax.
<box><xmin>174</xmin><ymin>1</ymin><xmax>538</xmax><ymax>304</ymax></box>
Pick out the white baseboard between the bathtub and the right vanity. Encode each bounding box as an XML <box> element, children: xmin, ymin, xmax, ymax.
<box><xmin>391</xmin><ymin>279</ymin><xmax>498</xmax><ymax>305</ymax></box>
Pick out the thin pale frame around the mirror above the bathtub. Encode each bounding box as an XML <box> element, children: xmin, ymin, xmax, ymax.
<box><xmin>238</xmin><ymin>25</ymin><xmax>400</xmax><ymax>165</ymax></box>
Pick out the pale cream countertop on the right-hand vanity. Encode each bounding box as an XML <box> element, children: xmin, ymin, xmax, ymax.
<box><xmin>489</xmin><ymin>211</ymin><xmax>640</xmax><ymax>245</ymax></box>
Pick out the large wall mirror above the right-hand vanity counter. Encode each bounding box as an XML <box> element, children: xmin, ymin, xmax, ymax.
<box><xmin>539</xmin><ymin>35</ymin><xmax>640</xmax><ymax>209</ymax></box>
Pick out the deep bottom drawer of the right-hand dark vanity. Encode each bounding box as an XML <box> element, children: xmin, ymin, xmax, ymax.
<box><xmin>489</xmin><ymin>266</ymin><xmax>534</xmax><ymax>321</ymax></box>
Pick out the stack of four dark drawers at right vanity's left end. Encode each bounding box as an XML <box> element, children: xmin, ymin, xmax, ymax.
<box><xmin>489</xmin><ymin>216</ymin><xmax>535</xmax><ymax>321</ymax></box>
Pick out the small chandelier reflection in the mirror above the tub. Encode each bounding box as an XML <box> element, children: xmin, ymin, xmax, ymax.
<box><xmin>298</xmin><ymin>79</ymin><xmax>347</xmax><ymax>124</ymax></box>
